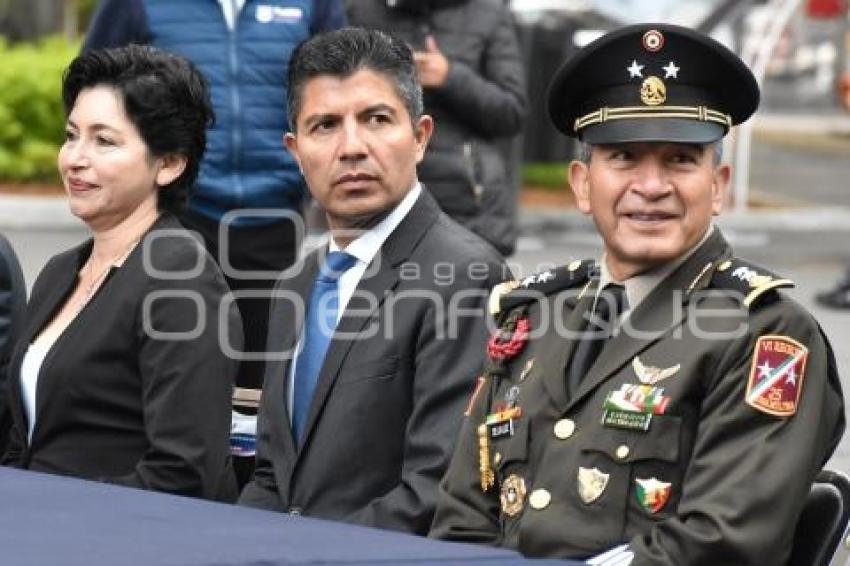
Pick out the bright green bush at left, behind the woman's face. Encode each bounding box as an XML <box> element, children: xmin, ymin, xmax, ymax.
<box><xmin>0</xmin><ymin>37</ymin><xmax>79</xmax><ymax>182</ymax></box>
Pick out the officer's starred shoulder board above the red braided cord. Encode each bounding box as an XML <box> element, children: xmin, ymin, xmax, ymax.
<box><xmin>489</xmin><ymin>259</ymin><xmax>596</xmax><ymax>316</ymax></box>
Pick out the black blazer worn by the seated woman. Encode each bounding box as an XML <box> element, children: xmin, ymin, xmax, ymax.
<box><xmin>5</xmin><ymin>214</ymin><xmax>242</xmax><ymax>499</ymax></box>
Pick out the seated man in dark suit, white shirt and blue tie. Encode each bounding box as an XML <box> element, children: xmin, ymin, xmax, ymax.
<box><xmin>235</xmin><ymin>28</ymin><xmax>506</xmax><ymax>534</ymax></box>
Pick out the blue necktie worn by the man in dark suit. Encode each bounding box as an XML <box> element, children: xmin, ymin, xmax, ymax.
<box><xmin>292</xmin><ymin>252</ymin><xmax>357</xmax><ymax>443</ymax></box>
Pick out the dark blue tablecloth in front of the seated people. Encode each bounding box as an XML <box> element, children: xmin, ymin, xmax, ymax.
<box><xmin>0</xmin><ymin>468</ymin><xmax>579</xmax><ymax>566</ymax></box>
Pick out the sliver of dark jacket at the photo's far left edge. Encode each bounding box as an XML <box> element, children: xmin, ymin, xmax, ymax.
<box><xmin>0</xmin><ymin>235</ymin><xmax>27</xmax><ymax>453</ymax></box>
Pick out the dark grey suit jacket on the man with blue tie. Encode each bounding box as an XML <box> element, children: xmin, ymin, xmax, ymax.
<box><xmin>240</xmin><ymin>191</ymin><xmax>507</xmax><ymax>533</ymax></box>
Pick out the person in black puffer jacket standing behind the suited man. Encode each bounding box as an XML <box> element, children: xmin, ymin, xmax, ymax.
<box><xmin>346</xmin><ymin>0</ymin><xmax>526</xmax><ymax>255</ymax></box>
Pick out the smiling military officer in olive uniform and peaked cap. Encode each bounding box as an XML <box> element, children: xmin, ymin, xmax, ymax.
<box><xmin>431</xmin><ymin>24</ymin><xmax>844</xmax><ymax>566</ymax></box>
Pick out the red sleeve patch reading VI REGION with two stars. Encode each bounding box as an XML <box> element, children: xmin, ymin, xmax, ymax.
<box><xmin>746</xmin><ymin>336</ymin><xmax>809</xmax><ymax>417</ymax></box>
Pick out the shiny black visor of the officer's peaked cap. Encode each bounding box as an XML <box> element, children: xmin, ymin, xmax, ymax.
<box><xmin>581</xmin><ymin>118</ymin><xmax>726</xmax><ymax>144</ymax></box>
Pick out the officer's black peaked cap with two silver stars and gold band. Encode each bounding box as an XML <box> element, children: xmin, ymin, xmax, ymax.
<box><xmin>548</xmin><ymin>24</ymin><xmax>759</xmax><ymax>144</ymax></box>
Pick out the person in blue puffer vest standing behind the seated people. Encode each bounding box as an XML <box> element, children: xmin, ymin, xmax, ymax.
<box><xmin>83</xmin><ymin>0</ymin><xmax>346</xmax><ymax>400</ymax></box>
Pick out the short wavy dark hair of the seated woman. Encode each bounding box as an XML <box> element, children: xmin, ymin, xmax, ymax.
<box><xmin>62</xmin><ymin>45</ymin><xmax>214</xmax><ymax>212</ymax></box>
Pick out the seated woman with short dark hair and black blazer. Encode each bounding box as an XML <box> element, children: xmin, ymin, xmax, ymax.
<box><xmin>5</xmin><ymin>46</ymin><xmax>242</xmax><ymax>499</ymax></box>
